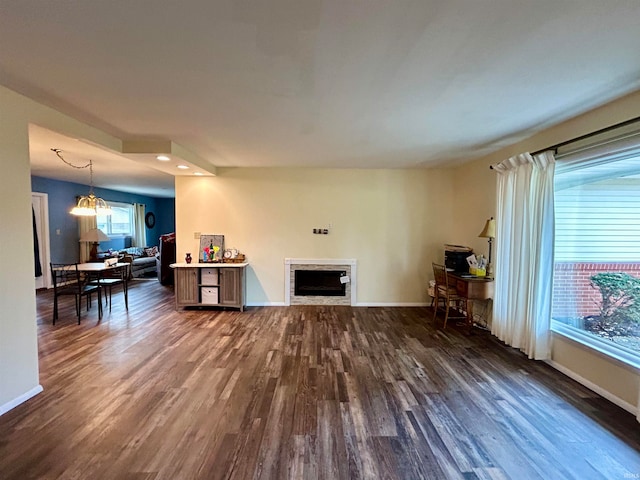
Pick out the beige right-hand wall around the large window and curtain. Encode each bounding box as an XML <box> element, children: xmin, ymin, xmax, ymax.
<box><xmin>453</xmin><ymin>88</ymin><xmax>640</xmax><ymax>414</ymax></box>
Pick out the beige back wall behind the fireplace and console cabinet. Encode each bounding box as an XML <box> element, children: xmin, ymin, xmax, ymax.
<box><xmin>176</xmin><ymin>168</ymin><xmax>453</xmax><ymax>305</ymax></box>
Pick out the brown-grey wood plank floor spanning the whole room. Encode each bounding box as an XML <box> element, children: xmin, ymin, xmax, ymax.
<box><xmin>0</xmin><ymin>280</ymin><xmax>640</xmax><ymax>480</ymax></box>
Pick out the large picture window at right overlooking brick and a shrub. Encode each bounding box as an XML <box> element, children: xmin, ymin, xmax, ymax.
<box><xmin>552</xmin><ymin>127</ymin><xmax>640</xmax><ymax>366</ymax></box>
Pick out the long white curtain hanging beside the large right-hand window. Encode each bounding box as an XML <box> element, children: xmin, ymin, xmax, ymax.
<box><xmin>491</xmin><ymin>152</ymin><xmax>555</xmax><ymax>360</ymax></box>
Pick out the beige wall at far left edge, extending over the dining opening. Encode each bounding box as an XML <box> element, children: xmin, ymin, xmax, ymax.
<box><xmin>0</xmin><ymin>86</ymin><xmax>124</xmax><ymax>414</ymax></box>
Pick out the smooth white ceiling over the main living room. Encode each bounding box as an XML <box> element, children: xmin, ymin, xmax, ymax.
<box><xmin>0</xmin><ymin>0</ymin><xmax>640</xmax><ymax>193</ymax></box>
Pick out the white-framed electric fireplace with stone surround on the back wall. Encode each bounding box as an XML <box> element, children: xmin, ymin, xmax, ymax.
<box><xmin>284</xmin><ymin>258</ymin><xmax>357</xmax><ymax>305</ymax></box>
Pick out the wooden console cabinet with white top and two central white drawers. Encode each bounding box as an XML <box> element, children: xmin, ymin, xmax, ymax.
<box><xmin>171</xmin><ymin>263</ymin><xmax>248</xmax><ymax>311</ymax></box>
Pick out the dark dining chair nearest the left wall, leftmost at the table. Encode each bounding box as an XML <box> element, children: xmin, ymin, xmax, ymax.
<box><xmin>49</xmin><ymin>263</ymin><xmax>102</xmax><ymax>325</ymax></box>
